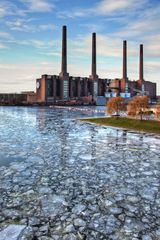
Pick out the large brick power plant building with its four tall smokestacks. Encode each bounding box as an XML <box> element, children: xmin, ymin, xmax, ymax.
<box><xmin>36</xmin><ymin>26</ymin><xmax>156</xmax><ymax>104</ymax></box>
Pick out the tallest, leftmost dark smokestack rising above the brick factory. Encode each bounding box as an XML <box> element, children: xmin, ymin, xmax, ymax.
<box><xmin>62</xmin><ymin>26</ymin><xmax>67</xmax><ymax>73</ymax></box>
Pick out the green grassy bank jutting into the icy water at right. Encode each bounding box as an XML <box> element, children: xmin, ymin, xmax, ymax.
<box><xmin>82</xmin><ymin>117</ymin><xmax>160</xmax><ymax>134</ymax></box>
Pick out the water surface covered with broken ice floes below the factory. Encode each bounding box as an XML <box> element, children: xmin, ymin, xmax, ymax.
<box><xmin>0</xmin><ymin>107</ymin><xmax>160</xmax><ymax>240</ymax></box>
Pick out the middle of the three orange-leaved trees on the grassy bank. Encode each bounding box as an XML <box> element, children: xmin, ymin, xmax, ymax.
<box><xmin>127</xmin><ymin>96</ymin><xmax>149</xmax><ymax>120</ymax></box>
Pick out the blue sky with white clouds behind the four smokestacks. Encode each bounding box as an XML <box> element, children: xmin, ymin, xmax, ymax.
<box><xmin>0</xmin><ymin>0</ymin><xmax>160</xmax><ymax>95</ymax></box>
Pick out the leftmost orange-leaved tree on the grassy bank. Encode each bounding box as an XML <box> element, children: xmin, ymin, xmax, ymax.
<box><xmin>107</xmin><ymin>97</ymin><xmax>125</xmax><ymax>117</ymax></box>
